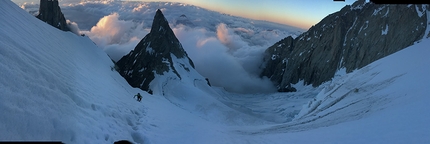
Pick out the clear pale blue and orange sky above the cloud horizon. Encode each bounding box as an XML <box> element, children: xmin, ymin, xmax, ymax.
<box><xmin>12</xmin><ymin>0</ymin><xmax>355</xmax><ymax>30</ymax></box>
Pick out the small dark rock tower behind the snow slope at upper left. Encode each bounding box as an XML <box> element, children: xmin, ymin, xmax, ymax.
<box><xmin>36</xmin><ymin>0</ymin><xmax>70</xmax><ymax>31</ymax></box>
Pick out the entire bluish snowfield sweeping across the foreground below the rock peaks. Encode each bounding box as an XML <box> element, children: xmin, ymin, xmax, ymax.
<box><xmin>0</xmin><ymin>1</ymin><xmax>430</xmax><ymax>144</ymax></box>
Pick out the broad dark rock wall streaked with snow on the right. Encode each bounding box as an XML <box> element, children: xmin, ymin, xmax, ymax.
<box><xmin>261</xmin><ymin>0</ymin><xmax>429</xmax><ymax>92</ymax></box>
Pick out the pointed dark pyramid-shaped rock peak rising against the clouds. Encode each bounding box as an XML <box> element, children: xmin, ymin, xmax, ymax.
<box><xmin>116</xmin><ymin>10</ymin><xmax>194</xmax><ymax>91</ymax></box>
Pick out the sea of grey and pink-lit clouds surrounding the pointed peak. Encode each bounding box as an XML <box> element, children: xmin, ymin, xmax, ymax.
<box><xmin>21</xmin><ymin>1</ymin><xmax>304</xmax><ymax>93</ymax></box>
